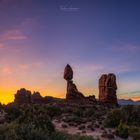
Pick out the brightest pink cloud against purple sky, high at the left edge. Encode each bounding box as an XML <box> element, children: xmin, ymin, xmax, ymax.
<box><xmin>0</xmin><ymin>29</ymin><xmax>28</xmax><ymax>41</ymax></box>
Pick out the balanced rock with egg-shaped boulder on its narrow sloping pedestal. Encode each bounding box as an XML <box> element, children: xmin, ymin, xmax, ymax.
<box><xmin>64</xmin><ymin>64</ymin><xmax>85</xmax><ymax>101</ymax></box>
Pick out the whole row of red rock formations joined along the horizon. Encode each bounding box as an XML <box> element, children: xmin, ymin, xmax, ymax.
<box><xmin>14</xmin><ymin>64</ymin><xmax>118</xmax><ymax>105</ymax></box>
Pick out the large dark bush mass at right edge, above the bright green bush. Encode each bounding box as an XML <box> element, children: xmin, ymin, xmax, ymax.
<box><xmin>104</xmin><ymin>105</ymin><xmax>140</xmax><ymax>127</ymax></box>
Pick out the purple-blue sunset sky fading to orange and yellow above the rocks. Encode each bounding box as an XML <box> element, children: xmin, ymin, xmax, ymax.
<box><xmin>0</xmin><ymin>0</ymin><xmax>140</xmax><ymax>103</ymax></box>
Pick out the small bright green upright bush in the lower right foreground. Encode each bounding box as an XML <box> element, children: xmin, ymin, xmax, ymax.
<box><xmin>116</xmin><ymin>121</ymin><xmax>129</xmax><ymax>138</ymax></box>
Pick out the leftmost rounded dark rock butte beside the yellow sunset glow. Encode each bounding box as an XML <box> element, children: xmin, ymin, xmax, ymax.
<box><xmin>14</xmin><ymin>88</ymin><xmax>31</xmax><ymax>105</ymax></box>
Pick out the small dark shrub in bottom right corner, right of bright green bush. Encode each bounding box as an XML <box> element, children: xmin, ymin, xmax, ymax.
<box><xmin>129</xmin><ymin>126</ymin><xmax>140</xmax><ymax>140</ymax></box>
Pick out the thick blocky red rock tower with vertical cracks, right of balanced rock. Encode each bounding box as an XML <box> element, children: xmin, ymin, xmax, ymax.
<box><xmin>99</xmin><ymin>73</ymin><xmax>117</xmax><ymax>104</ymax></box>
